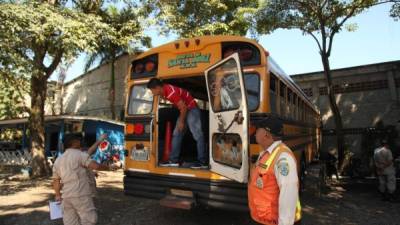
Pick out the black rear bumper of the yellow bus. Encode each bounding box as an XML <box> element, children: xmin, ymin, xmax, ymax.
<box><xmin>124</xmin><ymin>171</ymin><xmax>249</xmax><ymax>211</ymax></box>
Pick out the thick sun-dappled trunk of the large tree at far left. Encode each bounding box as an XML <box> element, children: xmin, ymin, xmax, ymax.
<box><xmin>29</xmin><ymin>74</ymin><xmax>49</xmax><ymax>177</ymax></box>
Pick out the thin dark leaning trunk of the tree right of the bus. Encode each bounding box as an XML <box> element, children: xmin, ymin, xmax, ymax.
<box><xmin>321</xmin><ymin>53</ymin><xmax>345</xmax><ymax>168</ymax></box>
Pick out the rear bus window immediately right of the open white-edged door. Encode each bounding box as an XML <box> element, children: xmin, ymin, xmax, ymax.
<box><xmin>244</xmin><ymin>73</ymin><xmax>260</xmax><ymax>112</ymax></box>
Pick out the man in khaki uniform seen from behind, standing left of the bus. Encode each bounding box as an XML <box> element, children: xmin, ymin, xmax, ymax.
<box><xmin>53</xmin><ymin>134</ymin><xmax>115</xmax><ymax>225</ymax></box>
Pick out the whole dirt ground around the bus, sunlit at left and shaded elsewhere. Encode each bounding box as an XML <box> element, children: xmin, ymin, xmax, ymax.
<box><xmin>0</xmin><ymin>165</ymin><xmax>400</xmax><ymax>225</ymax></box>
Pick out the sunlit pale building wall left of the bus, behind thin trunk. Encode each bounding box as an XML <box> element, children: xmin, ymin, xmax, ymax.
<box><xmin>59</xmin><ymin>54</ymin><xmax>132</xmax><ymax>120</ymax></box>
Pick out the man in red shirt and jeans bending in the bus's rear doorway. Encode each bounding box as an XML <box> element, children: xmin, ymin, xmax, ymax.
<box><xmin>147</xmin><ymin>78</ymin><xmax>208</xmax><ymax>169</ymax></box>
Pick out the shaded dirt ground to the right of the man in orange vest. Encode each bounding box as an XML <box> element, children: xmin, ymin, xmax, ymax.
<box><xmin>302</xmin><ymin>179</ymin><xmax>400</xmax><ymax>225</ymax></box>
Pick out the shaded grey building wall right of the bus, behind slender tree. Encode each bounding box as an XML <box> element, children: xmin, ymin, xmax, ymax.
<box><xmin>291</xmin><ymin>61</ymin><xmax>400</xmax><ymax>155</ymax></box>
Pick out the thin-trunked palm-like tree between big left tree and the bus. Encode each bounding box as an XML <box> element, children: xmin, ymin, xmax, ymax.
<box><xmin>85</xmin><ymin>5</ymin><xmax>150</xmax><ymax>119</ymax></box>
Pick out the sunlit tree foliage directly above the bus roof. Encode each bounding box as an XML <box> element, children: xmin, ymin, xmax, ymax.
<box><xmin>147</xmin><ymin>0</ymin><xmax>258</xmax><ymax>37</ymax></box>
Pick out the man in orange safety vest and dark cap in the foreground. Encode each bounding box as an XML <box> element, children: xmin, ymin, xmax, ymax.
<box><xmin>248</xmin><ymin>117</ymin><xmax>301</xmax><ymax>225</ymax></box>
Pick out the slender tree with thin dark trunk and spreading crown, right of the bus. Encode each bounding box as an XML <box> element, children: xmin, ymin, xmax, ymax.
<box><xmin>253</xmin><ymin>0</ymin><xmax>398</xmax><ymax>167</ymax></box>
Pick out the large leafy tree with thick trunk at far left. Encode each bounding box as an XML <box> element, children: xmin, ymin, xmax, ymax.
<box><xmin>0</xmin><ymin>0</ymin><xmax>112</xmax><ymax>176</ymax></box>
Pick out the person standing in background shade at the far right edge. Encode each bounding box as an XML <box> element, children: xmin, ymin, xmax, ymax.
<box><xmin>374</xmin><ymin>139</ymin><xmax>396</xmax><ymax>201</ymax></box>
